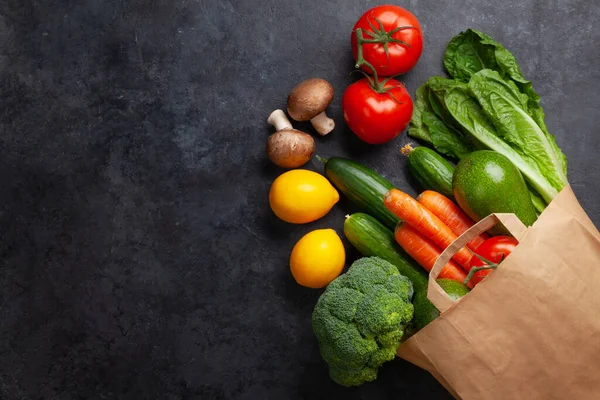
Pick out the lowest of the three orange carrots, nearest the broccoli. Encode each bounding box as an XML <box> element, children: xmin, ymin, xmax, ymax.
<box><xmin>394</xmin><ymin>222</ymin><xmax>467</xmax><ymax>283</ymax></box>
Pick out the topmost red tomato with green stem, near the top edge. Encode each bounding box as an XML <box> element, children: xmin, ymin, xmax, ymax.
<box><xmin>351</xmin><ymin>5</ymin><xmax>423</xmax><ymax>76</ymax></box>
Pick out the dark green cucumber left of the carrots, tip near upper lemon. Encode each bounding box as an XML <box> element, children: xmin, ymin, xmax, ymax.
<box><xmin>319</xmin><ymin>157</ymin><xmax>400</xmax><ymax>229</ymax></box>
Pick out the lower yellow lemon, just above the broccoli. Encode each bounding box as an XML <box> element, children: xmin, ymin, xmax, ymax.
<box><xmin>290</xmin><ymin>229</ymin><xmax>346</xmax><ymax>289</ymax></box>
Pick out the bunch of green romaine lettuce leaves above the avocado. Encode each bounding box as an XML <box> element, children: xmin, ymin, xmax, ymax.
<box><xmin>408</xmin><ymin>29</ymin><xmax>568</xmax><ymax>208</ymax></box>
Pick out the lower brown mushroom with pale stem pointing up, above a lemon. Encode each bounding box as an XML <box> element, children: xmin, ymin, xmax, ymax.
<box><xmin>267</xmin><ymin>110</ymin><xmax>315</xmax><ymax>168</ymax></box>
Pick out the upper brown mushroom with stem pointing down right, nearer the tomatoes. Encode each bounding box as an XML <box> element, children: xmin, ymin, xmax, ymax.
<box><xmin>288</xmin><ymin>78</ymin><xmax>335</xmax><ymax>136</ymax></box>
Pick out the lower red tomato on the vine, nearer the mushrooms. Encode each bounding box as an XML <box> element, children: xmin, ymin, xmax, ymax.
<box><xmin>342</xmin><ymin>78</ymin><xmax>413</xmax><ymax>144</ymax></box>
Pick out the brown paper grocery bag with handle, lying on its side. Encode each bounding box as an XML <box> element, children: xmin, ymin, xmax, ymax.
<box><xmin>398</xmin><ymin>187</ymin><xmax>600</xmax><ymax>400</ymax></box>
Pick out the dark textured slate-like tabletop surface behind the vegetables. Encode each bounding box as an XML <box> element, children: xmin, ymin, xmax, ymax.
<box><xmin>0</xmin><ymin>0</ymin><xmax>600</xmax><ymax>400</ymax></box>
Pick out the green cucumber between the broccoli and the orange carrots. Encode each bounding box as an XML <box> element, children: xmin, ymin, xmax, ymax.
<box><xmin>344</xmin><ymin>213</ymin><xmax>440</xmax><ymax>332</ymax></box>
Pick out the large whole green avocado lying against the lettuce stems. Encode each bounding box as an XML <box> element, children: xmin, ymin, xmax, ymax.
<box><xmin>452</xmin><ymin>150</ymin><xmax>537</xmax><ymax>235</ymax></box>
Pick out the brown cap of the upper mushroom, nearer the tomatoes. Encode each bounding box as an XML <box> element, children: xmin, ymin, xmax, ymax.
<box><xmin>288</xmin><ymin>78</ymin><xmax>333</xmax><ymax>121</ymax></box>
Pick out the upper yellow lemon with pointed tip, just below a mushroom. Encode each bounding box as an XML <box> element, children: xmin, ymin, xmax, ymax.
<box><xmin>269</xmin><ymin>169</ymin><xmax>340</xmax><ymax>224</ymax></box>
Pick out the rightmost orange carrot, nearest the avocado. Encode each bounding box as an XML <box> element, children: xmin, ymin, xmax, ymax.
<box><xmin>417</xmin><ymin>190</ymin><xmax>489</xmax><ymax>251</ymax></box>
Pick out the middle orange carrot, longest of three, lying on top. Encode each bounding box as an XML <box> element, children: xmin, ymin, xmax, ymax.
<box><xmin>383</xmin><ymin>189</ymin><xmax>473</xmax><ymax>269</ymax></box>
